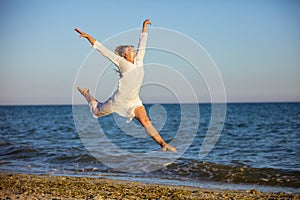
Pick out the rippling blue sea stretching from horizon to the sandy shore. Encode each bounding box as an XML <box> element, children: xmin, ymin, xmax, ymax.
<box><xmin>0</xmin><ymin>103</ymin><xmax>300</xmax><ymax>193</ymax></box>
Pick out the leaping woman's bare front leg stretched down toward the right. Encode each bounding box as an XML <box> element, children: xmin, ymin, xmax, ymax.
<box><xmin>134</xmin><ymin>106</ymin><xmax>176</xmax><ymax>152</ymax></box>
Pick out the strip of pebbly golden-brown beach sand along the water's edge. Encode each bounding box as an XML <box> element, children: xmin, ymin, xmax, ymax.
<box><xmin>0</xmin><ymin>173</ymin><xmax>300</xmax><ymax>199</ymax></box>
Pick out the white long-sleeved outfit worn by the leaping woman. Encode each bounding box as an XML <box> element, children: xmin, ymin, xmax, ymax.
<box><xmin>90</xmin><ymin>32</ymin><xmax>148</xmax><ymax>122</ymax></box>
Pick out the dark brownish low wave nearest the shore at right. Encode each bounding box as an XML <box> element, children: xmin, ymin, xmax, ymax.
<box><xmin>158</xmin><ymin>160</ymin><xmax>300</xmax><ymax>188</ymax></box>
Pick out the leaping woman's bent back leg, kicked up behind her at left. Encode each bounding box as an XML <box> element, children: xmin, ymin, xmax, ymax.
<box><xmin>77</xmin><ymin>86</ymin><xmax>112</xmax><ymax>118</ymax></box>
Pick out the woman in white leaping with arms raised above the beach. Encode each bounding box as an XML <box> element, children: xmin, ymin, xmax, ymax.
<box><xmin>75</xmin><ymin>19</ymin><xmax>176</xmax><ymax>152</ymax></box>
